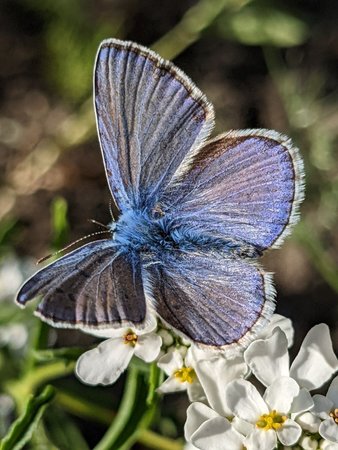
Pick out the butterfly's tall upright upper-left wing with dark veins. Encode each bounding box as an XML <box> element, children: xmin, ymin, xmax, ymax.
<box><xmin>94</xmin><ymin>39</ymin><xmax>213</xmax><ymax>211</ymax></box>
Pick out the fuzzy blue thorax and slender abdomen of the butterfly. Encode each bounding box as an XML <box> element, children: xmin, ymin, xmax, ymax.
<box><xmin>109</xmin><ymin>206</ymin><xmax>261</xmax><ymax>259</ymax></box>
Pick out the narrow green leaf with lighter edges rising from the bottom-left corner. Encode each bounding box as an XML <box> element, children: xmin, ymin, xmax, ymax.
<box><xmin>0</xmin><ymin>386</ymin><xmax>55</xmax><ymax>450</ymax></box>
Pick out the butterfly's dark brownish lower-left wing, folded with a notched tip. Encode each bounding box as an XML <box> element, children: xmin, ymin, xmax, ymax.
<box><xmin>16</xmin><ymin>240</ymin><xmax>146</xmax><ymax>329</ymax></box>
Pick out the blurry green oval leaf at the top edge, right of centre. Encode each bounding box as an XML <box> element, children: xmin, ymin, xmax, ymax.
<box><xmin>217</xmin><ymin>1</ymin><xmax>309</xmax><ymax>47</ymax></box>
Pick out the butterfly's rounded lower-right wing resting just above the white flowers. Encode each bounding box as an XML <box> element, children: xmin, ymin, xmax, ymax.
<box><xmin>145</xmin><ymin>251</ymin><xmax>274</xmax><ymax>349</ymax></box>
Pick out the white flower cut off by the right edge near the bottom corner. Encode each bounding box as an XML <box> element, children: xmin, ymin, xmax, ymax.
<box><xmin>313</xmin><ymin>376</ymin><xmax>338</xmax><ymax>444</ymax></box>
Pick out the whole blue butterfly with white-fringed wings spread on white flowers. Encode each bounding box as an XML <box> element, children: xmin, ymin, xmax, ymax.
<box><xmin>16</xmin><ymin>39</ymin><xmax>304</xmax><ymax>349</ymax></box>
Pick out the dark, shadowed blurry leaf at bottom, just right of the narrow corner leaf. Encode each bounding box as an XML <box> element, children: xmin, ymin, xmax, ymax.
<box><xmin>44</xmin><ymin>405</ymin><xmax>88</xmax><ymax>450</ymax></box>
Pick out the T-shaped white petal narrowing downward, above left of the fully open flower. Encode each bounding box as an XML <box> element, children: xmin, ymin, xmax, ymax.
<box><xmin>195</xmin><ymin>356</ymin><xmax>248</xmax><ymax>416</ymax></box>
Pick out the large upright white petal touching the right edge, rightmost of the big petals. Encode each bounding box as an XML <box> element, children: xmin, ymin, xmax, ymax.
<box><xmin>290</xmin><ymin>323</ymin><xmax>338</xmax><ymax>391</ymax></box>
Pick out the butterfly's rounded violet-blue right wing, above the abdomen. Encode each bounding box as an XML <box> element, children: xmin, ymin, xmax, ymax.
<box><xmin>160</xmin><ymin>130</ymin><xmax>304</xmax><ymax>251</ymax></box>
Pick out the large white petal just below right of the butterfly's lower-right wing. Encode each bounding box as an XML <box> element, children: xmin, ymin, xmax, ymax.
<box><xmin>244</xmin><ymin>328</ymin><xmax>289</xmax><ymax>386</ymax></box>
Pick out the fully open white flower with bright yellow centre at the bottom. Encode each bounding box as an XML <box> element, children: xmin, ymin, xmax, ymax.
<box><xmin>225</xmin><ymin>377</ymin><xmax>302</xmax><ymax>450</ymax></box>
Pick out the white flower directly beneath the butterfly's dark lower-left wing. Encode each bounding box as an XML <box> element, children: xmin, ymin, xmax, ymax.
<box><xmin>75</xmin><ymin>321</ymin><xmax>162</xmax><ymax>385</ymax></box>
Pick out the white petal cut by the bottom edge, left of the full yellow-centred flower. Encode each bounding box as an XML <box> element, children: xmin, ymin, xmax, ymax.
<box><xmin>191</xmin><ymin>417</ymin><xmax>244</xmax><ymax>450</ymax></box>
